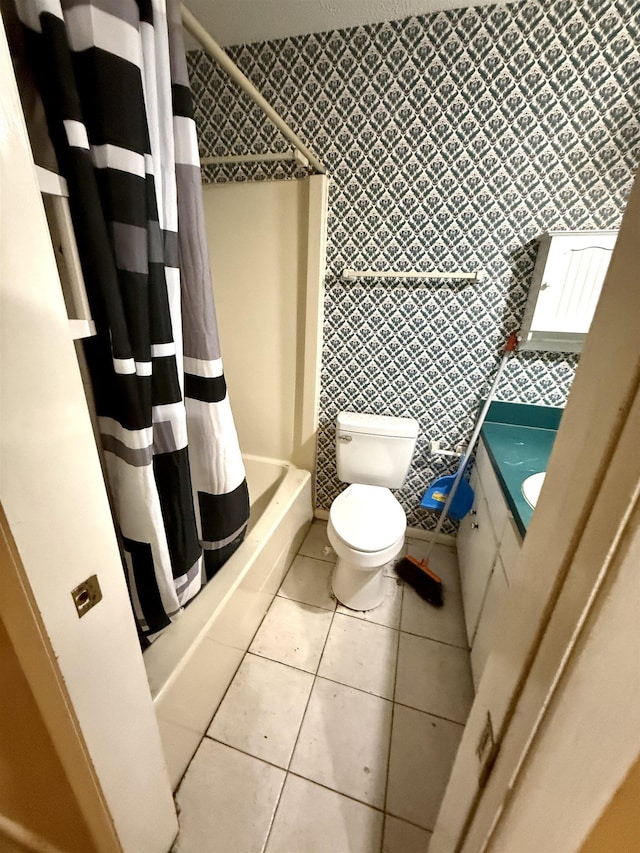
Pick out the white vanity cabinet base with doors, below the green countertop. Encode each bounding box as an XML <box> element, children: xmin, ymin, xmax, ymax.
<box><xmin>457</xmin><ymin>442</ymin><xmax>522</xmax><ymax>688</ymax></box>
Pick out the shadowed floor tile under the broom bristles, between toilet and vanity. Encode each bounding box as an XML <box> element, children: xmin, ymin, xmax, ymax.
<box><xmin>400</xmin><ymin>583</ymin><xmax>468</xmax><ymax>649</ymax></box>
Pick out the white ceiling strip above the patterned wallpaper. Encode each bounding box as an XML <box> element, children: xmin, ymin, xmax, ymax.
<box><xmin>185</xmin><ymin>0</ymin><xmax>496</xmax><ymax>48</ymax></box>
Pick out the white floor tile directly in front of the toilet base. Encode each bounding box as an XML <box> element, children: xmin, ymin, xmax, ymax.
<box><xmin>318</xmin><ymin>613</ymin><xmax>398</xmax><ymax>699</ymax></box>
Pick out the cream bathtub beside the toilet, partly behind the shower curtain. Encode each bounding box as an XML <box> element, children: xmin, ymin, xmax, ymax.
<box><xmin>144</xmin><ymin>456</ymin><xmax>313</xmax><ymax>788</ymax></box>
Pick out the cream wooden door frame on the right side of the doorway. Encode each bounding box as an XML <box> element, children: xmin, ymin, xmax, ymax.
<box><xmin>429</xmin><ymin>175</ymin><xmax>640</xmax><ymax>853</ymax></box>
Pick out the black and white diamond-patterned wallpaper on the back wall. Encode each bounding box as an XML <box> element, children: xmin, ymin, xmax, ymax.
<box><xmin>189</xmin><ymin>0</ymin><xmax>640</xmax><ymax>528</ymax></box>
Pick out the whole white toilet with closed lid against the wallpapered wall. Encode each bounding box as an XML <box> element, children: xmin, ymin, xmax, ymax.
<box><xmin>327</xmin><ymin>412</ymin><xmax>418</xmax><ymax>610</ymax></box>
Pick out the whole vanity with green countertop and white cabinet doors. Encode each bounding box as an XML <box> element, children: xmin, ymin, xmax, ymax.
<box><xmin>457</xmin><ymin>402</ymin><xmax>563</xmax><ymax>689</ymax></box>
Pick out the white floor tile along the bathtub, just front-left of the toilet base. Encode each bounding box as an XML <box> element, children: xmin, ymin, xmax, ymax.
<box><xmin>249</xmin><ymin>596</ymin><xmax>333</xmax><ymax>672</ymax></box>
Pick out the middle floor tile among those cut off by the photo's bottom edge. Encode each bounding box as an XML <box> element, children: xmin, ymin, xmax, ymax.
<box><xmin>266</xmin><ymin>774</ymin><xmax>382</xmax><ymax>853</ymax></box>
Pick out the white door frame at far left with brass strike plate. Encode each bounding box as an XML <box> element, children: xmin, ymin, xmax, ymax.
<box><xmin>0</xmin><ymin>18</ymin><xmax>177</xmax><ymax>853</ymax></box>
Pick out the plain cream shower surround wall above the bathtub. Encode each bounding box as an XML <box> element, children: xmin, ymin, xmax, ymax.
<box><xmin>203</xmin><ymin>176</ymin><xmax>309</xmax><ymax>464</ymax></box>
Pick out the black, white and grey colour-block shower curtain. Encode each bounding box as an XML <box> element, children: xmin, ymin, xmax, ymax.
<box><xmin>16</xmin><ymin>0</ymin><xmax>249</xmax><ymax>639</ymax></box>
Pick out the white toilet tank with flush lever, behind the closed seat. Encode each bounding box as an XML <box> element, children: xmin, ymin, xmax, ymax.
<box><xmin>336</xmin><ymin>412</ymin><xmax>418</xmax><ymax>489</ymax></box>
